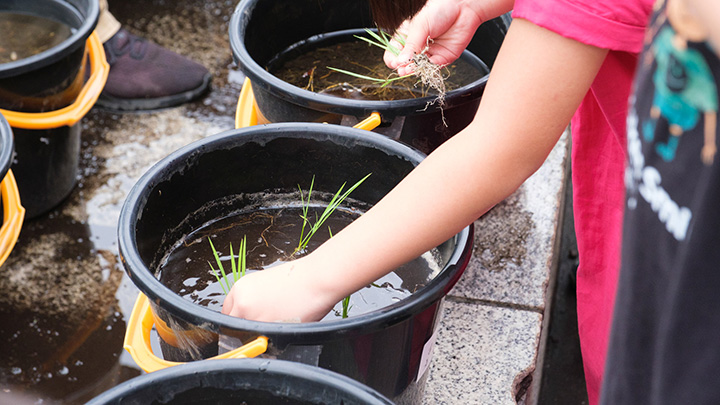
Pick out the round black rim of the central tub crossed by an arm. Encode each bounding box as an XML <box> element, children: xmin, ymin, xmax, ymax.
<box><xmin>118</xmin><ymin>123</ymin><xmax>473</xmax><ymax>341</ymax></box>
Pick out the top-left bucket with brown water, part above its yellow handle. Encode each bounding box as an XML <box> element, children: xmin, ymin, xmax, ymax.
<box><xmin>0</xmin><ymin>0</ymin><xmax>100</xmax><ymax>112</ymax></box>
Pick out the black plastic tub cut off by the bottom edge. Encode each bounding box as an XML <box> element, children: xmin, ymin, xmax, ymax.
<box><xmin>87</xmin><ymin>359</ymin><xmax>392</xmax><ymax>405</ymax></box>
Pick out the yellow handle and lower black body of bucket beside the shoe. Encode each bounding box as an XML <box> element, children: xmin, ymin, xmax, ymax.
<box><xmin>0</xmin><ymin>33</ymin><xmax>110</xmax><ymax>218</ymax></box>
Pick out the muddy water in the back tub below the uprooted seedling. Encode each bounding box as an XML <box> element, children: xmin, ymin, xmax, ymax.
<box><xmin>267</xmin><ymin>34</ymin><xmax>488</xmax><ymax>100</ymax></box>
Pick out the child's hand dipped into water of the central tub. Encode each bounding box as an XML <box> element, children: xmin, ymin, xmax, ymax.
<box><xmin>222</xmin><ymin>258</ymin><xmax>338</xmax><ymax>322</ymax></box>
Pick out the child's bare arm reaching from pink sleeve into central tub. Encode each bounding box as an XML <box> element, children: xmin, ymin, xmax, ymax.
<box><xmin>223</xmin><ymin>19</ymin><xmax>606</xmax><ymax>321</ymax></box>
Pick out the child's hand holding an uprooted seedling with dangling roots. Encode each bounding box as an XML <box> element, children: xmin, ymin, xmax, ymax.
<box><xmin>384</xmin><ymin>0</ymin><xmax>484</xmax><ymax>76</ymax></box>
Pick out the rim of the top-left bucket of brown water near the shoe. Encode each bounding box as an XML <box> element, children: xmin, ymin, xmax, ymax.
<box><xmin>0</xmin><ymin>0</ymin><xmax>100</xmax><ymax>79</ymax></box>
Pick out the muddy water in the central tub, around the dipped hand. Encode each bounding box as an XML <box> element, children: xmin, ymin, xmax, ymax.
<box><xmin>158</xmin><ymin>196</ymin><xmax>440</xmax><ymax>320</ymax></box>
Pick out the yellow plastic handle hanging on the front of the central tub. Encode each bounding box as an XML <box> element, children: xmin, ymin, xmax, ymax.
<box><xmin>123</xmin><ymin>293</ymin><xmax>268</xmax><ymax>373</ymax></box>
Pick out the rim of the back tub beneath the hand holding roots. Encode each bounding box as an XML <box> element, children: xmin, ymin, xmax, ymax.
<box><xmin>229</xmin><ymin>0</ymin><xmax>490</xmax><ymax>118</ymax></box>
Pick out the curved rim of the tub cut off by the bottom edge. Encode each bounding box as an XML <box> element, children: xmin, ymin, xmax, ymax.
<box><xmin>87</xmin><ymin>359</ymin><xmax>393</xmax><ymax>405</ymax></box>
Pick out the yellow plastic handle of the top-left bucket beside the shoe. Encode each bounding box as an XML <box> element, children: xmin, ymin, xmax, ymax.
<box><xmin>0</xmin><ymin>31</ymin><xmax>110</xmax><ymax>129</ymax></box>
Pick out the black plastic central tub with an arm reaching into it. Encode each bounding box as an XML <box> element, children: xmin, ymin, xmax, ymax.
<box><xmin>118</xmin><ymin>123</ymin><xmax>473</xmax><ymax>403</ymax></box>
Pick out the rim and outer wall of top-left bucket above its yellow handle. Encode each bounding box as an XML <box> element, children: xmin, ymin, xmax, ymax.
<box><xmin>0</xmin><ymin>0</ymin><xmax>100</xmax><ymax>112</ymax></box>
